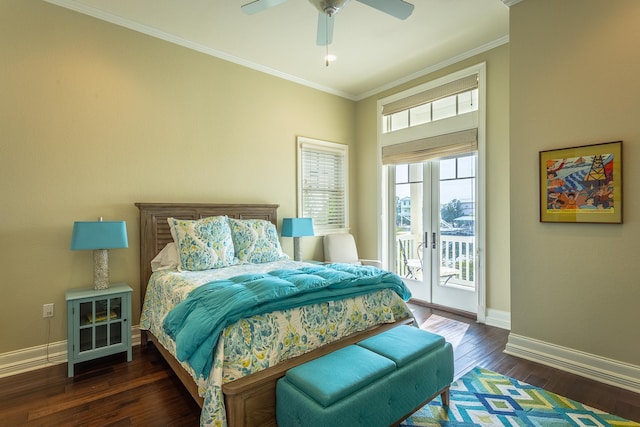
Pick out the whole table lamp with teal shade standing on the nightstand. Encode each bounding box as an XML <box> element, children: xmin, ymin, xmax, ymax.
<box><xmin>71</xmin><ymin>217</ymin><xmax>129</xmax><ymax>289</ymax></box>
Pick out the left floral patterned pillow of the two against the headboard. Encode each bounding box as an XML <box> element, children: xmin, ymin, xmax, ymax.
<box><xmin>167</xmin><ymin>216</ymin><xmax>236</xmax><ymax>271</ymax></box>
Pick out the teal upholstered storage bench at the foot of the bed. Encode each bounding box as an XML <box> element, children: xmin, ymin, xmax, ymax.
<box><xmin>276</xmin><ymin>325</ymin><xmax>453</xmax><ymax>427</ymax></box>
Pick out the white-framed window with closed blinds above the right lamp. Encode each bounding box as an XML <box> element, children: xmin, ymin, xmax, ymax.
<box><xmin>298</xmin><ymin>137</ymin><xmax>349</xmax><ymax>234</ymax></box>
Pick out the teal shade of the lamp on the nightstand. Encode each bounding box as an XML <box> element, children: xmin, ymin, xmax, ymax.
<box><xmin>71</xmin><ymin>221</ymin><xmax>129</xmax><ymax>251</ymax></box>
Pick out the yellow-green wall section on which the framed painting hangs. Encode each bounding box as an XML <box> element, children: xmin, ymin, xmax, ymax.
<box><xmin>510</xmin><ymin>0</ymin><xmax>640</xmax><ymax>365</ymax></box>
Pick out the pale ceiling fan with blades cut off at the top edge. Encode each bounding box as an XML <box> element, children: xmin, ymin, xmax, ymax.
<box><xmin>242</xmin><ymin>0</ymin><xmax>413</xmax><ymax>46</ymax></box>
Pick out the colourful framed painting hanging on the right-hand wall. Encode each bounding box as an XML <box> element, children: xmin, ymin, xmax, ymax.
<box><xmin>540</xmin><ymin>141</ymin><xmax>622</xmax><ymax>224</ymax></box>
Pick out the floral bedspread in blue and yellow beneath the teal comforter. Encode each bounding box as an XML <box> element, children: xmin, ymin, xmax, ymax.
<box><xmin>140</xmin><ymin>260</ymin><xmax>412</xmax><ymax>426</ymax></box>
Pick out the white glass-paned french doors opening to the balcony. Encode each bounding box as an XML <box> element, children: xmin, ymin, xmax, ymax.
<box><xmin>389</xmin><ymin>152</ymin><xmax>478</xmax><ymax>314</ymax></box>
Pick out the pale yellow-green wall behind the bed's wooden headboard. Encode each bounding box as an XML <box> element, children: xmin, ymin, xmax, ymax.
<box><xmin>0</xmin><ymin>0</ymin><xmax>357</xmax><ymax>354</ymax></box>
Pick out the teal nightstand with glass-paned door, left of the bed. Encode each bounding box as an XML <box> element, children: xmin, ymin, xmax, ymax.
<box><xmin>65</xmin><ymin>283</ymin><xmax>132</xmax><ymax>377</ymax></box>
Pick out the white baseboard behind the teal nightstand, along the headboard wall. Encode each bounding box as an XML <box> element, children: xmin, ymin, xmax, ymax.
<box><xmin>0</xmin><ymin>326</ymin><xmax>140</xmax><ymax>378</ymax></box>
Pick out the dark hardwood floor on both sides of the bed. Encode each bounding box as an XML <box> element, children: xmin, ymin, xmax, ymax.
<box><xmin>0</xmin><ymin>305</ymin><xmax>640</xmax><ymax>427</ymax></box>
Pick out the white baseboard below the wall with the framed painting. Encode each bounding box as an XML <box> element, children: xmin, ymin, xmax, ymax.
<box><xmin>505</xmin><ymin>333</ymin><xmax>640</xmax><ymax>393</ymax></box>
